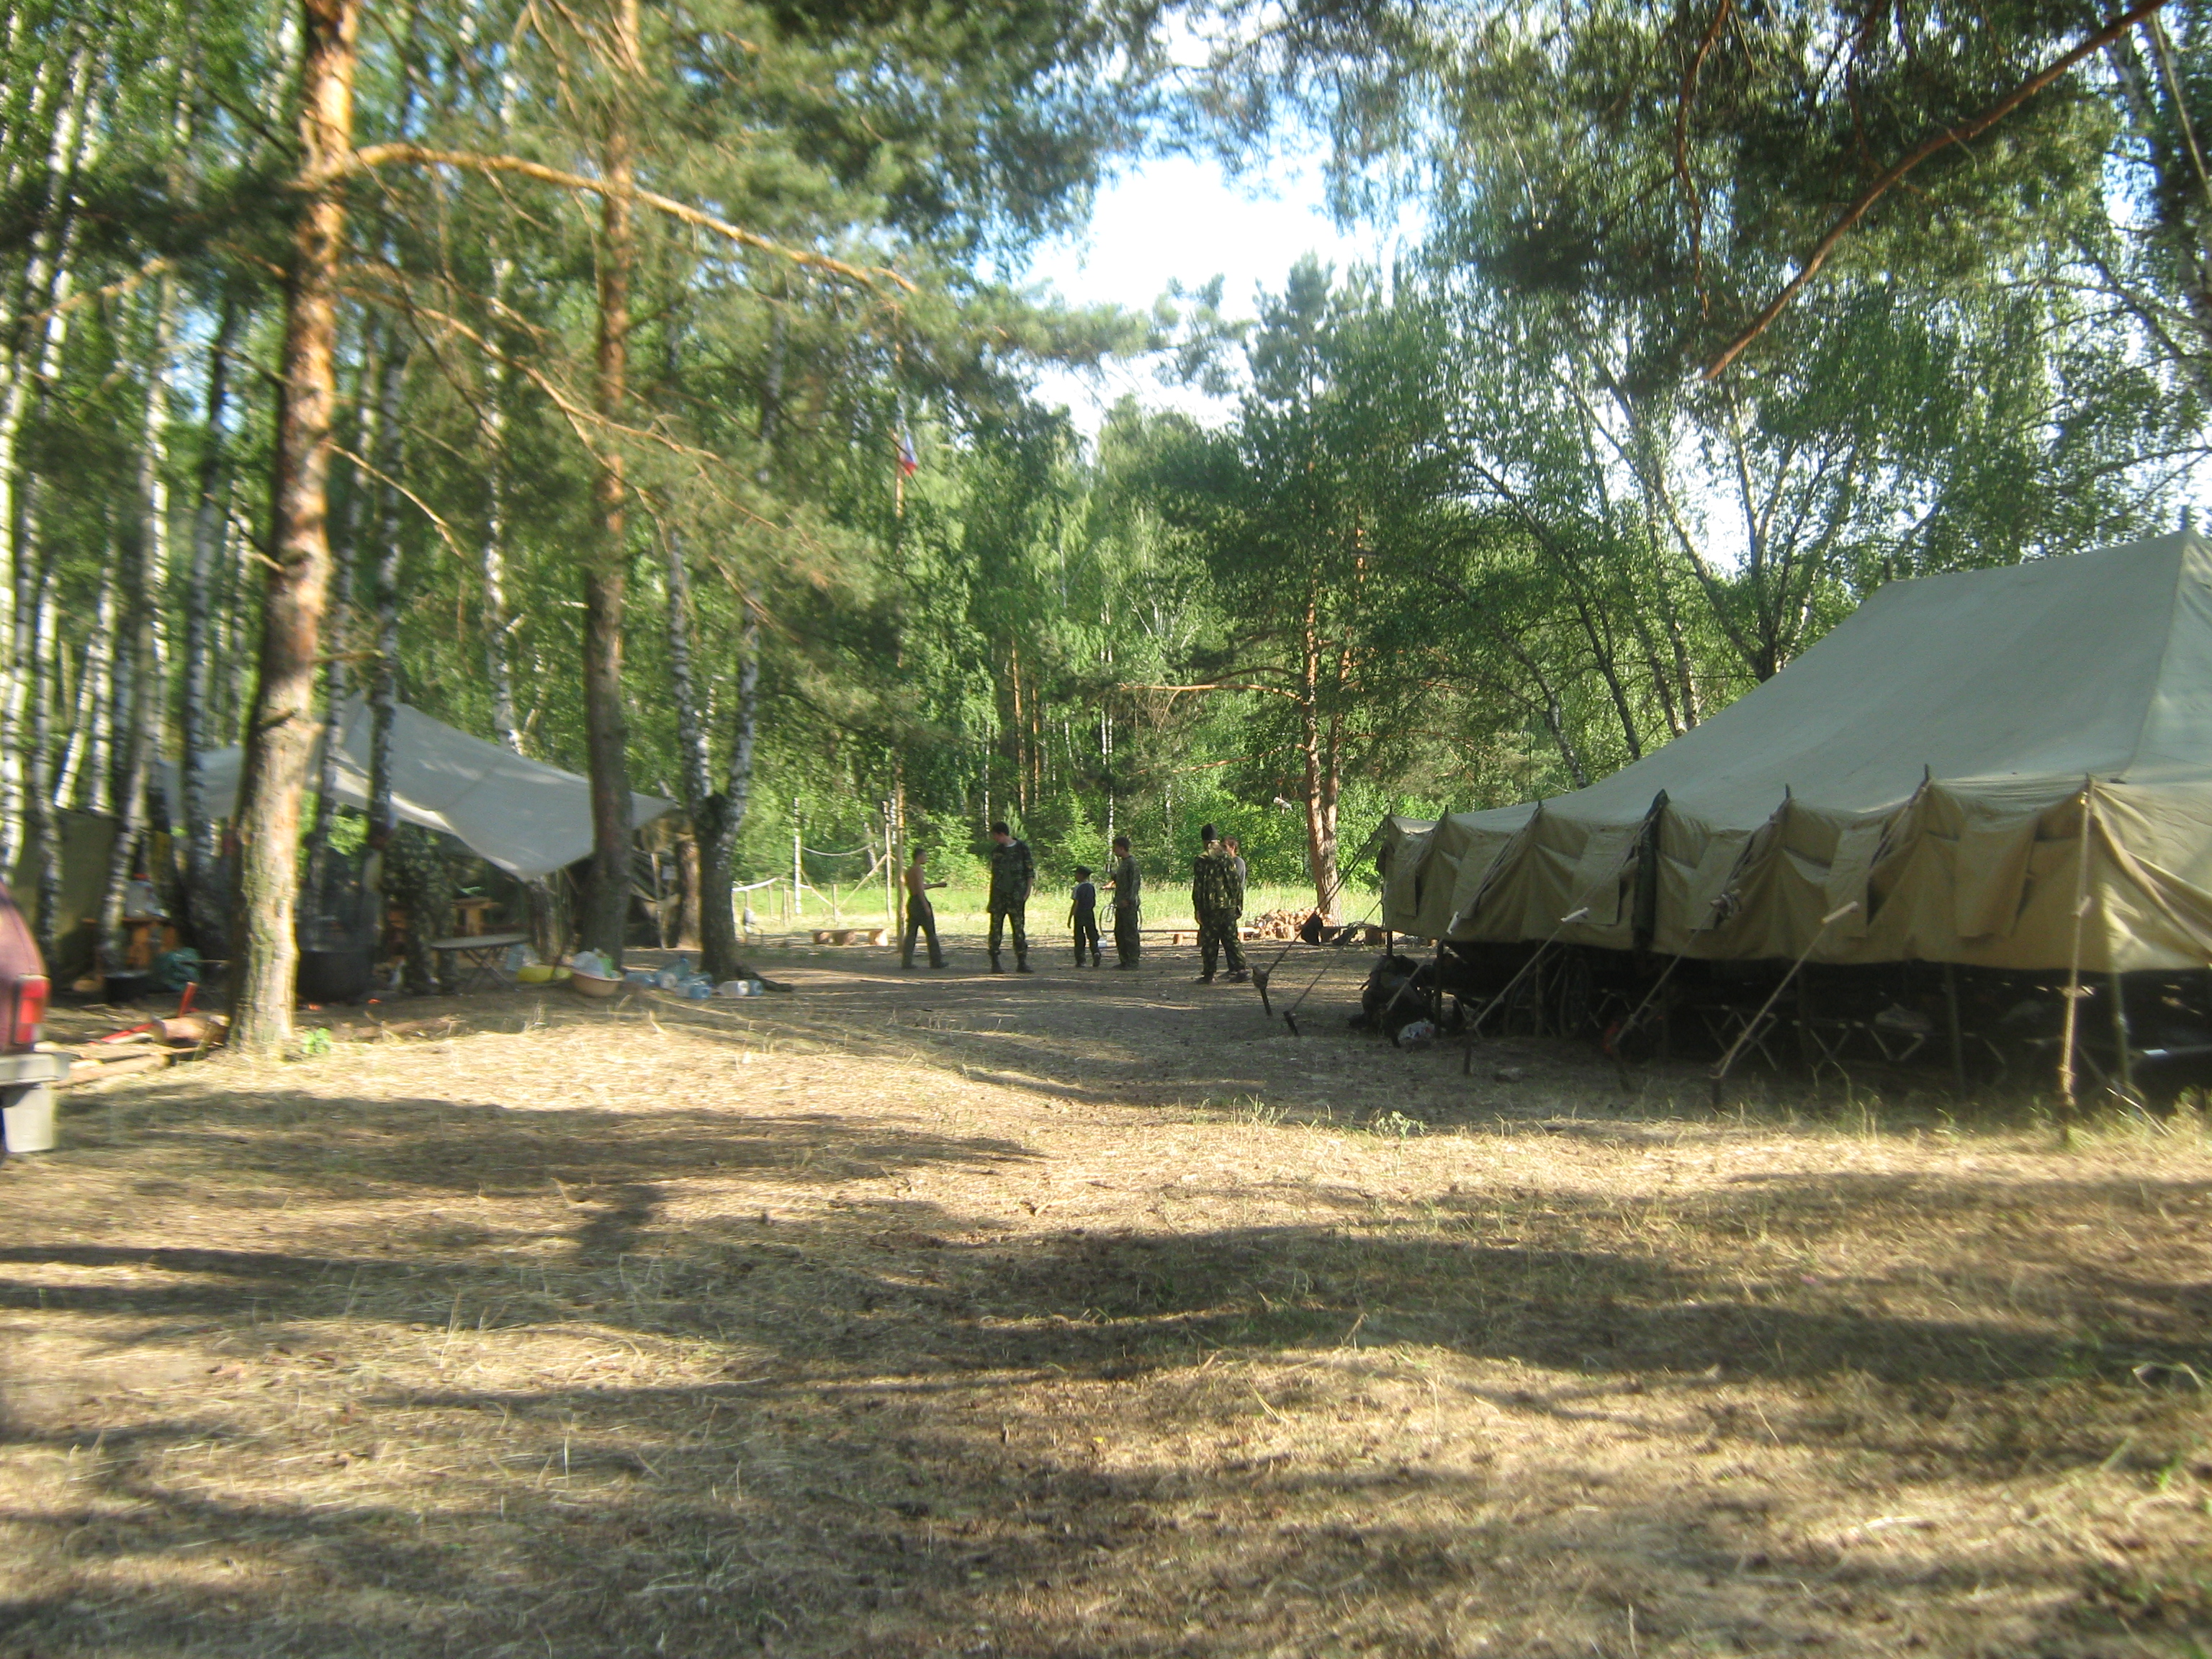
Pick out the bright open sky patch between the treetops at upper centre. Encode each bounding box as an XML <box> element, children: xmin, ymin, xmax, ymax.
<box><xmin>1028</xmin><ymin>155</ymin><xmax>1395</xmax><ymax>433</ymax></box>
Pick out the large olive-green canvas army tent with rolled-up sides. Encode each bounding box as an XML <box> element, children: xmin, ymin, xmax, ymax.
<box><xmin>1382</xmin><ymin>533</ymin><xmax>2212</xmax><ymax>974</ymax></box>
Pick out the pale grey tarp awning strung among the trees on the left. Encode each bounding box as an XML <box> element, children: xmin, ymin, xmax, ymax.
<box><xmin>168</xmin><ymin>697</ymin><xmax>677</xmax><ymax>878</ymax></box>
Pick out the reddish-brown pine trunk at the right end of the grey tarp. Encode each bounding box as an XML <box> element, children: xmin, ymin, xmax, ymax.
<box><xmin>582</xmin><ymin>0</ymin><xmax>639</xmax><ymax>966</ymax></box>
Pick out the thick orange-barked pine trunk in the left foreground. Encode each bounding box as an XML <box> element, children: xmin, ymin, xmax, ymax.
<box><xmin>230</xmin><ymin>0</ymin><xmax>361</xmax><ymax>1053</ymax></box>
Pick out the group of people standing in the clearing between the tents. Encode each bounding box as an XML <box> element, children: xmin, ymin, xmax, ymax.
<box><xmin>898</xmin><ymin>823</ymin><xmax>1250</xmax><ymax>984</ymax></box>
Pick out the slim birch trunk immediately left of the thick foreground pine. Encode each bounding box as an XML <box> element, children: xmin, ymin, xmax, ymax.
<box><xmin>177</xmin><ymin>295</ymin><xmax>239</xmax><ymax>956</ymax></box>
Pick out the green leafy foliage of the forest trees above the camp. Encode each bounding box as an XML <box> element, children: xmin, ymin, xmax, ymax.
<box><xmin>0</xmin><ymin>0</ymin><xmax>2212</xmax><ymax>946</ymax></box>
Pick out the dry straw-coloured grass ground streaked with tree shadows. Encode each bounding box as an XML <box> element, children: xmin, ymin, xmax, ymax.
<box><xmin>0</xmin><ymin>951</ymin><xmax>2212</xmax><ymax>1659</ymax></box>
